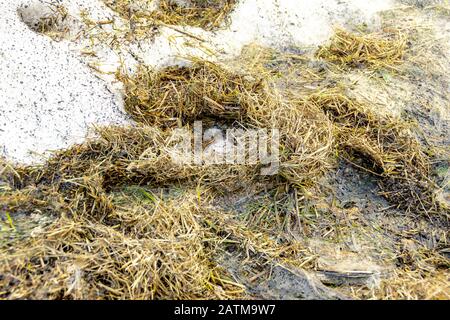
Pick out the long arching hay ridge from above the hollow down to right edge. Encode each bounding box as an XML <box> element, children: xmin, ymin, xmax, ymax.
<box><xmin>122</xmin><ymin>57</ymin><xmax>439</xmax><ymax>212</ymax></box>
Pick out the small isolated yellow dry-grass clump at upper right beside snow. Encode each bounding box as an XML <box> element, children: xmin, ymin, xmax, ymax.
<box><xmin>317</xmin><ymin>29</ymin><xmax>407</xmax><ymax>69</ymax></box>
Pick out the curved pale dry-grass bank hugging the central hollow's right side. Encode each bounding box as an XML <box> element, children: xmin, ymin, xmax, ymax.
<box><xmin>245</xmin><ymin>85</ymin><xmax>335</xmax><ymax>187</ymax></box>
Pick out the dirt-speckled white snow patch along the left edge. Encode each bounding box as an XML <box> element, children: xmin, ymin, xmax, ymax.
<box><xmin>0</xmin><ymin>0</ymin><xmax>126</xmax><ymax>163</ymax></box>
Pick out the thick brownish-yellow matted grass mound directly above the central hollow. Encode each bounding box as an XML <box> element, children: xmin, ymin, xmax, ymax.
<box><xmin>120</xmin><ymin>61</ymin><xmax>258</xmax><ymax>126</ymax></box>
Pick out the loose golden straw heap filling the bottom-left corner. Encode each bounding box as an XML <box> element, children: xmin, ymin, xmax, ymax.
<box><xmin>0</xmin><ymin>189</ymin><xmax>243</xmax><ymax>299</ymax></box>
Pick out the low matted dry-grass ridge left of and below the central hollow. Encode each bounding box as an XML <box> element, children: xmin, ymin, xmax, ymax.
<box><xmin>27</xmin><ymin>125</ymin><xmax>266</xmax><ymax>195</ymax></box>
